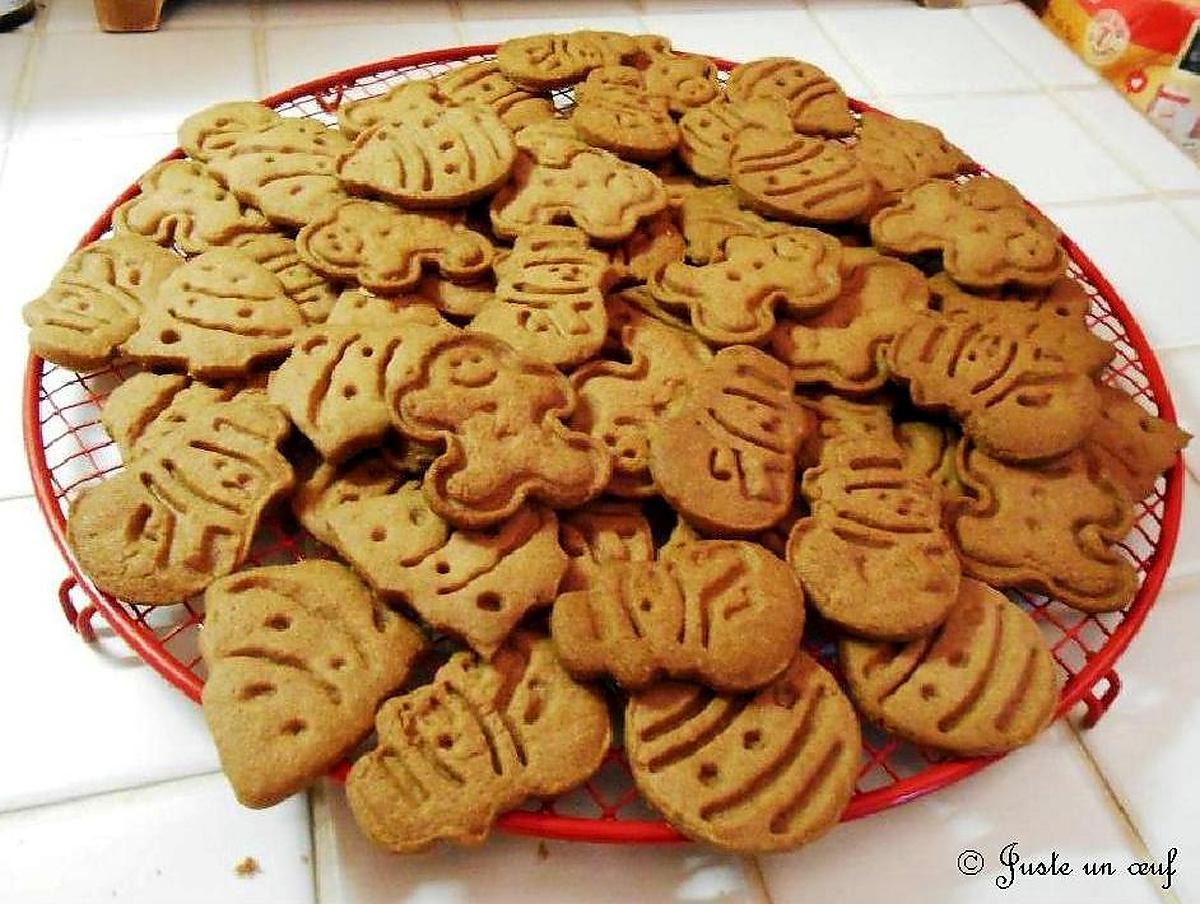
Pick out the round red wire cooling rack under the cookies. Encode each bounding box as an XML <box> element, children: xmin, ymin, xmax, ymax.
<box><xmin>24</xmin><ymin>46</ymin><xmax>1183</xmax><ymax>843</ymax></box>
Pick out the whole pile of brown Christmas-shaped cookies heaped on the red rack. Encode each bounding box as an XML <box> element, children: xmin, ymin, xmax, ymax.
<box><xmin>25</xmin><ymin>31</ymin><xmax>1188</xmax><ymax>851</ymax></box>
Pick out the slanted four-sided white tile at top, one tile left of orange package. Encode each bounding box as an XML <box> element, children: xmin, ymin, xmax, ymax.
<box><xmin>814</xmin><ymin>4</ymin><xmax>1034</xmax><ymax>94</ymax></box>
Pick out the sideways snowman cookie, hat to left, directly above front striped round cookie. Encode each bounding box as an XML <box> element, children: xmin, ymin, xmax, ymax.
<box><xmin>550</xmin><ymin>540</ymin><xmax>804</xmax><ymax>693</ymax></box>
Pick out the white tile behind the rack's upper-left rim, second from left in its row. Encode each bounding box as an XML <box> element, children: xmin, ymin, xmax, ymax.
<box><xmin>266</xmin><ymin>22</ymin><xmax>462</xmax><ymax>92</ymax></box>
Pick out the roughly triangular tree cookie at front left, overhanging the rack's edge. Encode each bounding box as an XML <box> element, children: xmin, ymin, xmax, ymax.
<box><xmin>200</xmin><ymin>559</ymin><xmax>425</xmax><ymax>808</ymax></box>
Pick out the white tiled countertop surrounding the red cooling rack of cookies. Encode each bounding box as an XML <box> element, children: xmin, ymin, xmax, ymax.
<box><xmin>0</xmin><ymin>0</ymin><xmax>1200</xmax><ymax>904</ymax></box>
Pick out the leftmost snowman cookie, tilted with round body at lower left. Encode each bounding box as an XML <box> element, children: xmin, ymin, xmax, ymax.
<box><xmin>67</xmin><ymin>390</ymin><xmax>293</xmax><ymax>605</ymax></box>
